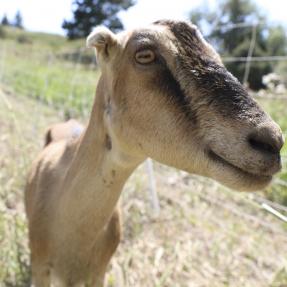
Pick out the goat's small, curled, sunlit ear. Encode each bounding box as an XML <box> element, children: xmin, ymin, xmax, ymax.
<box><xmin>87</xmin><ymin>26</ymin><xmax>117</xmax><ymax>57</ymax></box>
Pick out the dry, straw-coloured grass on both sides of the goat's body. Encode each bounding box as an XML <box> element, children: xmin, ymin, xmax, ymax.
<box><xmin>0</xmin><ymin>88</ymin><xmax>287</xmax><ymax>287</ymax></box>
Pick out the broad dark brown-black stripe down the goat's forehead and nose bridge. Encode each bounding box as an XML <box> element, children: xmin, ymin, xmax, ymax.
<box><xmin>155</xmin><ymin>20</ymin><xmax>264</xmax><ymax>118</ymax></box>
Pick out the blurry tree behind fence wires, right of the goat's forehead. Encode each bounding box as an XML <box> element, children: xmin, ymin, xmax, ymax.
<box><xmin>191</xmin><ymin>0</ymin><xmax>282</xmax><ymax>90</ymax></box>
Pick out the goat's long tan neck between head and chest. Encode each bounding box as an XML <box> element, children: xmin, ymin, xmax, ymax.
<box><xmin>58</xmin><ymin>75</ymin><xmax>143</xmax><ymax>241</ymax></box>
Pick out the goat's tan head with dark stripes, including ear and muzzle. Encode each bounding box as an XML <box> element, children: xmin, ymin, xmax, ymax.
<box><xmin>87</xmin><ymin>20</ymin><xmax>283</xmax><ymax>190</ymax></box>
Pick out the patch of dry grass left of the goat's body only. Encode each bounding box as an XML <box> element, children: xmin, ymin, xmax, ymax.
<box><xmin>0</xmin><ymin>89</ymin><xmax>59</xmax><ymax>287</ymax></box>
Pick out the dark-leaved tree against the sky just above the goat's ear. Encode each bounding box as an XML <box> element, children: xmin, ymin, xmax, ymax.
<box><xmin>62</xmin><ymin>0</ymin><xmax>134</xmax><ymax>39</ymax></box>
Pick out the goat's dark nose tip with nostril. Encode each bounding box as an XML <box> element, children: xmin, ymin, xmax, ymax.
<box><xmin>248</xmin><ymin>123</ymin><xmax>284</xmax><ymax>154</ymax></box>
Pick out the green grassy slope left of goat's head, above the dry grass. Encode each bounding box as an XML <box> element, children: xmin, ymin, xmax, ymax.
<box><xmin>0</xmin><ymin>25</ymin><xmax>99</xmax><ymax>118</ymax></box>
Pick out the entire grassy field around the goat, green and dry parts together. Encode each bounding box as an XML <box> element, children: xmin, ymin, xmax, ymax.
<box><xmin>0</xmin><ymin>25</ymin><xmax>287</xmax><ymax>287</ymax></box>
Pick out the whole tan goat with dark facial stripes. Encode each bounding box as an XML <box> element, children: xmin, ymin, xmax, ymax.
<box><xmin>25</xmin><ymin>21</ymin><xmax>283</xmax><ymax>287</ymax></box>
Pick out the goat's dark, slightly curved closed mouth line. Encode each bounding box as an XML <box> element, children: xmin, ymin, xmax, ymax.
<box><xmin>208</xmin><ymin>149</ymin><xmax>272</xmax><ymax>184</ymax></box>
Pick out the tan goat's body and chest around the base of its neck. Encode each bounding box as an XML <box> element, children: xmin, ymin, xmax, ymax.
<box><xmin>25</xmin><ymin>122</ymin><xmax>121</xmax><ymax>286</ymax></box>
